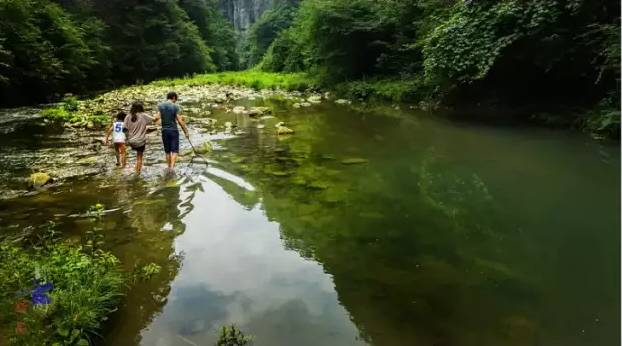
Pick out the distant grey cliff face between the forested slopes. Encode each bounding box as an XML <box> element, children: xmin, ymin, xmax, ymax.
<box><xmin>220</xmin><ymin>0</ymin><xmax>276</xmax><ymax>31</ymax></box>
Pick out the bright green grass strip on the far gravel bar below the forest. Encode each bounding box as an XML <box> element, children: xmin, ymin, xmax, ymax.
<box><xmin>150</xmin><ymin>70</ymin><xmax>318</xmax><ymax>91</ymax></box>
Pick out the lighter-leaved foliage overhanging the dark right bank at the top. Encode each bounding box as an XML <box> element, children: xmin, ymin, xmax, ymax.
<box><xmin>423</xmin><ymin>0</ymin><xmax>560</xmax><ymax>82</ymax></box>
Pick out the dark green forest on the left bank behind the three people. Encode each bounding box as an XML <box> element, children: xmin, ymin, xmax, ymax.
<box><xmin>0</xmin><ymin>0</ymin><xmax>238</xmax><ymax>104</ymax></box>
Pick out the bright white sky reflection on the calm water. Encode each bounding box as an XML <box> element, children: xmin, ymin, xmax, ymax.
<box><xmin>142</xmin><ymin>181</ymin><xmax>360</xmax><ymax>345</ymax></box>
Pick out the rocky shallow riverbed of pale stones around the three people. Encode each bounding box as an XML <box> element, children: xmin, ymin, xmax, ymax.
<box><xmin>0</xmin><ymin>85</ymin><xmax>350</xmax><ymax>199</ymax></box>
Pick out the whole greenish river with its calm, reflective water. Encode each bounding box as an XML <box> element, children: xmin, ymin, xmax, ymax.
<box><xmin>0</xmin><ymin>94</ymin><xmax>620</xmax><ymax>346</ymax></box>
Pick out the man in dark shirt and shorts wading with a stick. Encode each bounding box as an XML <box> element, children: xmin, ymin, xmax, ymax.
<box><xmin>155</xmin><ymin>91</ymin><xmax>190</xmax><ymax>172</ymax></box>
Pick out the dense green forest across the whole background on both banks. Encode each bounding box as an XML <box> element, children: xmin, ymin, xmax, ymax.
<box><xmin>0</xmin><ymin>0</ymin><xmax>620</xmax><ymax>134</ymax></box>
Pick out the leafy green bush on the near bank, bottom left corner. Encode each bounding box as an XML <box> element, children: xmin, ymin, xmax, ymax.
<box><xmin>0</xmin><ymin>242</ymin><xmax>125</xmax><ymax>345</ymax></box>
